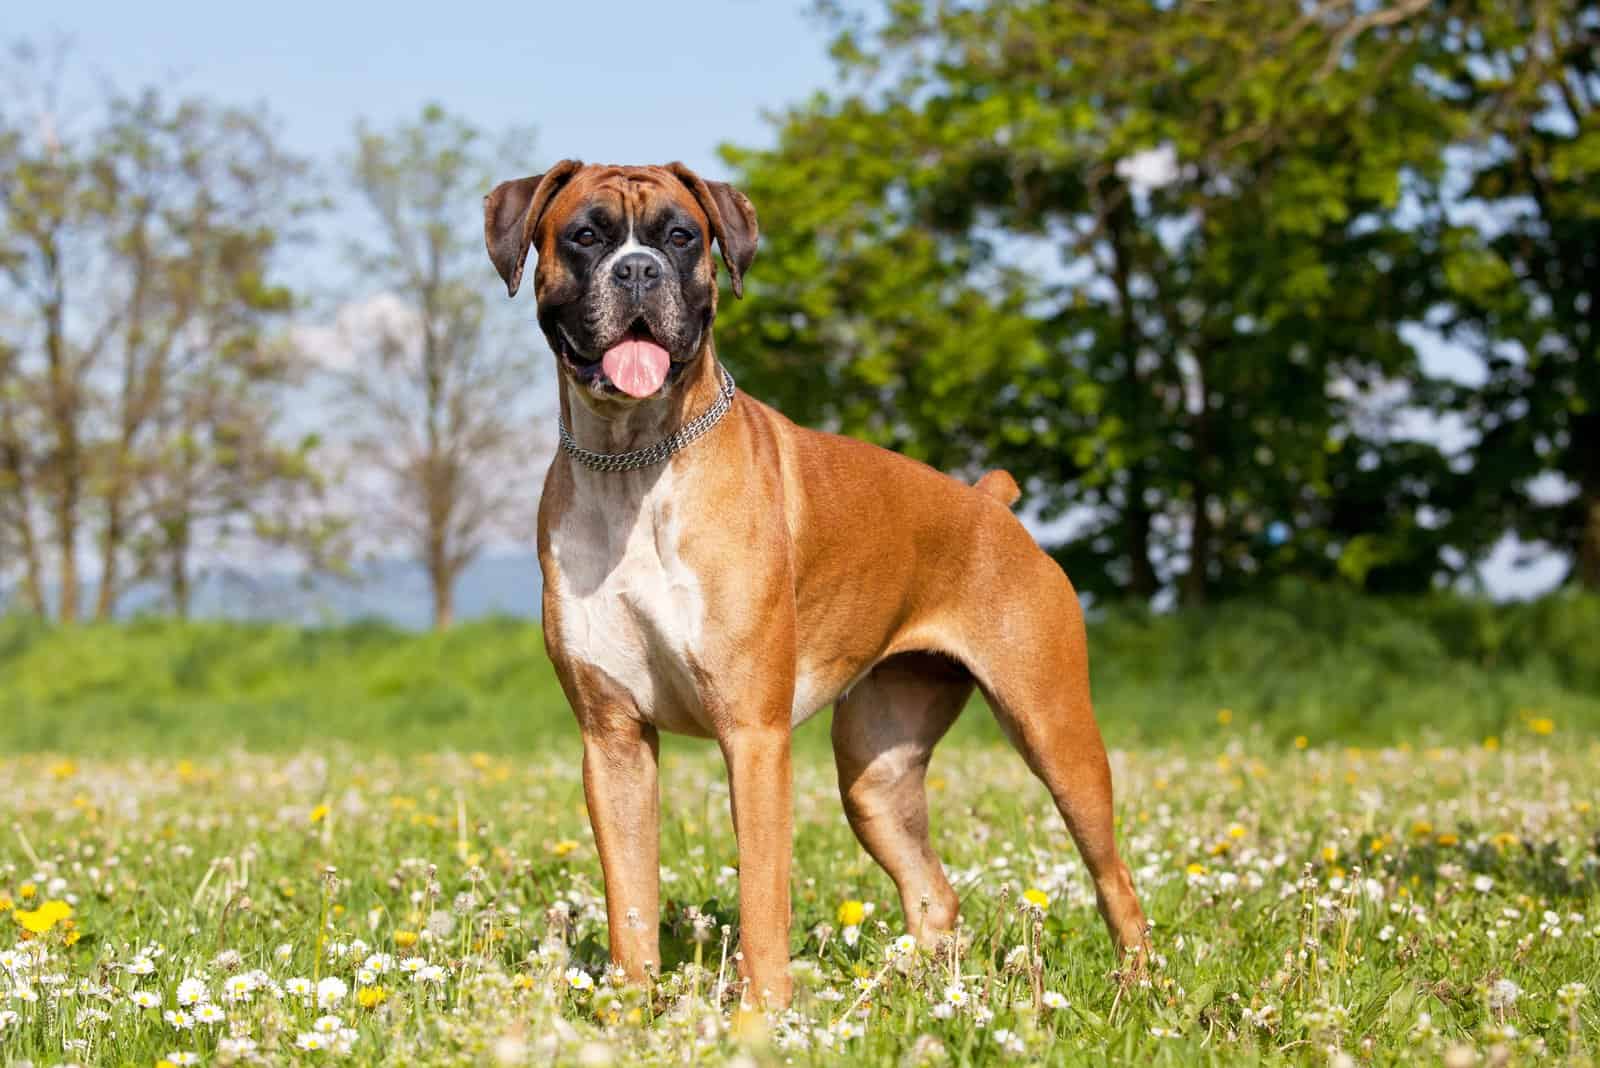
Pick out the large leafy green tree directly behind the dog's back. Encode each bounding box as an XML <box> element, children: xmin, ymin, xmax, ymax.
<box><xmin>720</xmin><ymin>0</ymin><xmax>1459</xmax><ymax>601</ymax></box>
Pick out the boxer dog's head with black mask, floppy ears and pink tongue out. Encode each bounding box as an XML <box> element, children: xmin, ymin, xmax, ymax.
<box><xmin>483</xmin><ymin>160</ymin><xmax>757</xmax><ymax>403</ymax></box>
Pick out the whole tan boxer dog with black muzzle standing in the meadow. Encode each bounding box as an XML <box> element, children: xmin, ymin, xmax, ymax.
<box><xmin>483</xmin><ymin>160</ymin><xmax>1146</xmax><ymax>1006</ymax></box>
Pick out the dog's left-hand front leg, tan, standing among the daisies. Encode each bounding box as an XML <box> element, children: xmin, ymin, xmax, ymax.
<box><xmin>582</xmin><ymin>711</ymin><xmax>661</xmax><ymax>982</ymax></box>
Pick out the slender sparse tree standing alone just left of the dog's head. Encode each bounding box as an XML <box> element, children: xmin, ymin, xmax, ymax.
<box><xmin>342</xmin><ymin>106</ymin><xmax>538</xmax><ymax>627</ymax></box>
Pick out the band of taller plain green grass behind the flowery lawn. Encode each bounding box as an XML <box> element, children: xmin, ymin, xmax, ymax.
<box><xmin>0</xmin><ymin>584</ymin><xmax>1600</xmax><ymax>753</ymax></box>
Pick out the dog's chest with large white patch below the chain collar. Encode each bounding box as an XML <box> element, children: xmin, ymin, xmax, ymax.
<box><xmin>550</xmin><ymin>468</ymin><xmax>706</xmax><ymax>732</ymax></box>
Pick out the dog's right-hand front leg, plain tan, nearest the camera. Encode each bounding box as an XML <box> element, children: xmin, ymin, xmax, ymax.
<box><xmin>722</xmin><ymin>722</ymin><xmax>794</xmax><ymax>1007</ymax></box>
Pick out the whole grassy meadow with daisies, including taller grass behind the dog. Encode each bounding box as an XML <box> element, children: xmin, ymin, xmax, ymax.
<box><xmin>0</xmin><ymin>587</ymin><xmax>1600</xmax><ymax>1065</ymax></box>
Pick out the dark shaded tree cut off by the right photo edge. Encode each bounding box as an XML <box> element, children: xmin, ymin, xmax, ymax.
<box><xmin>1426</xmin><ymin>0</ymin><xmax>1600</xmax><ymax>590</ymax></box>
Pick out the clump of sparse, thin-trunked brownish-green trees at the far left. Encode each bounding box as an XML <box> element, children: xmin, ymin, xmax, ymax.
<box><xmin>0</xmin><ymin>46</ymin><xmax>323</xmax><ymax>620</ymax></box>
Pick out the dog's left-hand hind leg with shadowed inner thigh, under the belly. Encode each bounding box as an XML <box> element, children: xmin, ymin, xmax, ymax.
<box><xmin>834</xmin><ymin>654</ymin><xmax>973</xmax><ymax>945</ymax></box>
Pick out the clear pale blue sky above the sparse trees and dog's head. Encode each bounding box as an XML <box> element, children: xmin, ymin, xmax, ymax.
<box><xmin>15</xmin><ymin>0</ymin><xmax>832</xmax><ymax>176</ymax></box>
